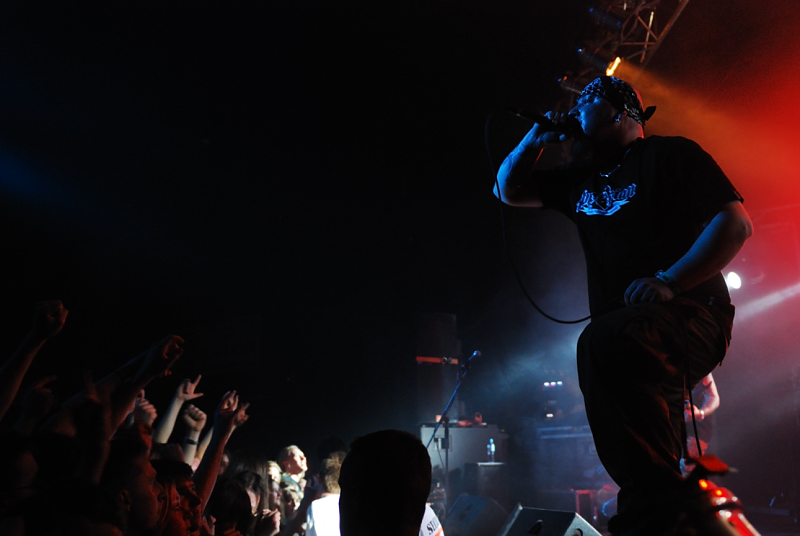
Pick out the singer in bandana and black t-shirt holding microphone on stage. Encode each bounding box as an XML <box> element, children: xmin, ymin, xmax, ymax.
<box><xmin>494</xmin><ymin>76</ymin><xmax>752</xmax><ymax>534</ymax></box>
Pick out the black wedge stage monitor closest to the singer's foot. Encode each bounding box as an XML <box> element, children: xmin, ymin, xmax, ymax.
<box><xmin>494</xmin><ymin>504</ymin><xmax>600</xmax><ymax>536</ymax></box>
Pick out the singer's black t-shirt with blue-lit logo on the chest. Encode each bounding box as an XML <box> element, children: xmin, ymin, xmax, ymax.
<box><xmin>535</xmin><ymin>136</ymin><xmax>742</xmax><ymax>315</ymax></box>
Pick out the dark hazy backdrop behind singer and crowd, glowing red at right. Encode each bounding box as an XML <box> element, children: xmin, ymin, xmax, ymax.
<box><xmin>0</xmin><ymin>0</ymin><xmax>800</xmax><ymax>520</ymax></box>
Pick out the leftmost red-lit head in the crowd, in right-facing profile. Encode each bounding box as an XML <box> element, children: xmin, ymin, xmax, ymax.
<box><xmin>101</xmin><ymin>427</ymin><xmax>167</xmax><ymax>536</ymax></box>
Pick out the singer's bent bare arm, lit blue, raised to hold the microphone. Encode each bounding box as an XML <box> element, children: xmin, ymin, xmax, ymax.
<box><xmin>494</xmin><ymin>119</ymin><xmax>568</xmax><ymax>207</ymax></box>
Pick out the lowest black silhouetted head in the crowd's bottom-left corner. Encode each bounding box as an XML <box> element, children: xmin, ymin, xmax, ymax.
<box><xmin>22</xmin><ymin>478</ymin><xmax>125</xmax><ymax>536</ymax></box>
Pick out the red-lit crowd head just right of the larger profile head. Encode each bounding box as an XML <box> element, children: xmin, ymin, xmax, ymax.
<box><xmin>151</xmin><ymin>459</ymin><xmax>203</xmax><ymax>536</ymax></box>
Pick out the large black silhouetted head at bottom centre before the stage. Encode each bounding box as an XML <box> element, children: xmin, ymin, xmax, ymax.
<box><xmin>339</xmin><ymin>430</ymin><xmax>431</xmax><ymax>536</ymax></box>
